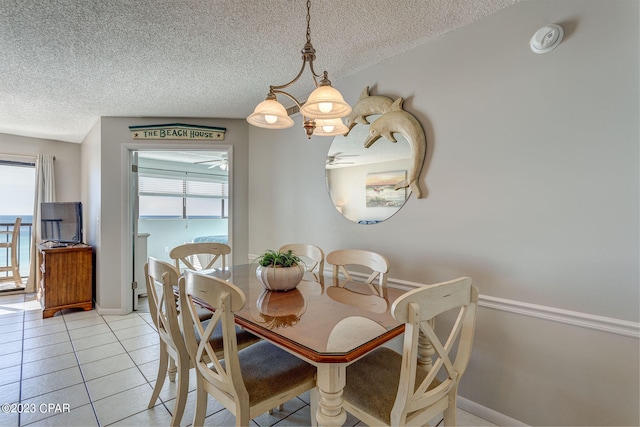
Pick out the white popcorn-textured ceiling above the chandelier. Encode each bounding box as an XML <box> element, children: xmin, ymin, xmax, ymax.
<box><xmin>0</xmin><ymin>0</ymin><xmax>520</xmax><ymax>142</ymax></box>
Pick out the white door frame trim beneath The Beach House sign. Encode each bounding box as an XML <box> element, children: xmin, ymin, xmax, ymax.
<box><xmin>120</xmin><ymin>144</ymin><xmax>234</xmax><ymax>313</ymax></box>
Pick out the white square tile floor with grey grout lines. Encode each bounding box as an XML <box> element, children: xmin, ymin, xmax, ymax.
<box><xmin>0</xmin><ymin>295</ymin><xmax>493</xmax><ymax>426</ymax></box>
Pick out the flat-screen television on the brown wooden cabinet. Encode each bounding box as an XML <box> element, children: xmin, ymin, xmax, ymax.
<box><xmin>40</xmin><ymin>202</ymin><xmax>82</xmax><ymax>244</ymax></box>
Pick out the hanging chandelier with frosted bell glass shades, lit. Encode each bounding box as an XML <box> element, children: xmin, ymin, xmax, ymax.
<box><xmin>247</xmin><ymin>0</ymin><xmax>351</xmax><ymax>138</ymax></box>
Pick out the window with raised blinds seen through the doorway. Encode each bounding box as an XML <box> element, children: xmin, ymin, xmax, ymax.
<box><xmin>138</xmin><ymin>168</ymin><xmax>229</xmax><ymax>219</ymax></box>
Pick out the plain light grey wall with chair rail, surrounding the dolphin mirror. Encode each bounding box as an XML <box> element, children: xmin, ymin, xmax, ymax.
<box><xmin>249</xmin><ymin>0</ymin><xmax>640</xmax><ymax>425</ymax></box>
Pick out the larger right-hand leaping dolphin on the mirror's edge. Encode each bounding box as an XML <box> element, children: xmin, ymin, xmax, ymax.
<box><xmin>364</xmin><ymin>98</ymin><xmax>427</xmax><ymax>199</ymax></box>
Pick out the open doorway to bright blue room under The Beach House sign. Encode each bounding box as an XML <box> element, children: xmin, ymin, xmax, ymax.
<box><xmin>131</xmin><ymin>147</ymin><xmax>232</xmax><ymax>311</ymax></box>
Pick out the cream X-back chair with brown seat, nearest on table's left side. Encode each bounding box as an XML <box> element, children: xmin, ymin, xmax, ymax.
<box><xmin>180</xmin><ymin>271</ymin><xmax>316</xmax><ymax>426</ymax></box>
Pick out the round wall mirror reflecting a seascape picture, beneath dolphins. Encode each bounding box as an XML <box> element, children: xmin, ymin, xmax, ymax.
<box><xmin>325</xmin><ymin>115</ymin><xmax>412</xmax><ymax>224</ymax></box>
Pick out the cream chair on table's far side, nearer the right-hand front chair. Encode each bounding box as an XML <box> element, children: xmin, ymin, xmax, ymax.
<box><xmin>327</xmin><ymin>249</ymin><xmax>389</xmax><ymax>295</ymax></box>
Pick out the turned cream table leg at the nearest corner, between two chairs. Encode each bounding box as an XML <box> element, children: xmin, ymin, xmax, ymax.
<box><xmin>315</xmin><ymin>363</ymin><xmax>347</xmax><ymax>427</ymax></box>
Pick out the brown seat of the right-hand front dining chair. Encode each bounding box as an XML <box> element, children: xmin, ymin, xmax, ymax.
<box><xmin>343</xmin><ymin>347</ymin><xmax>437</xmax><ymax>425</ymax></box>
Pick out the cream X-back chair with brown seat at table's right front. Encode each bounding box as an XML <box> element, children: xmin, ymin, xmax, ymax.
<box><xmin>342</xmin><ymin>277</ymin><xmax>478</xmax><ymax>426</ymax></box>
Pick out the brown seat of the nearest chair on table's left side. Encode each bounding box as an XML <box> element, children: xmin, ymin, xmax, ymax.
<box><xmin>238</xmin><ymin>341</ymin><xmax>316</xmax><ymax>406</ymax></box>
